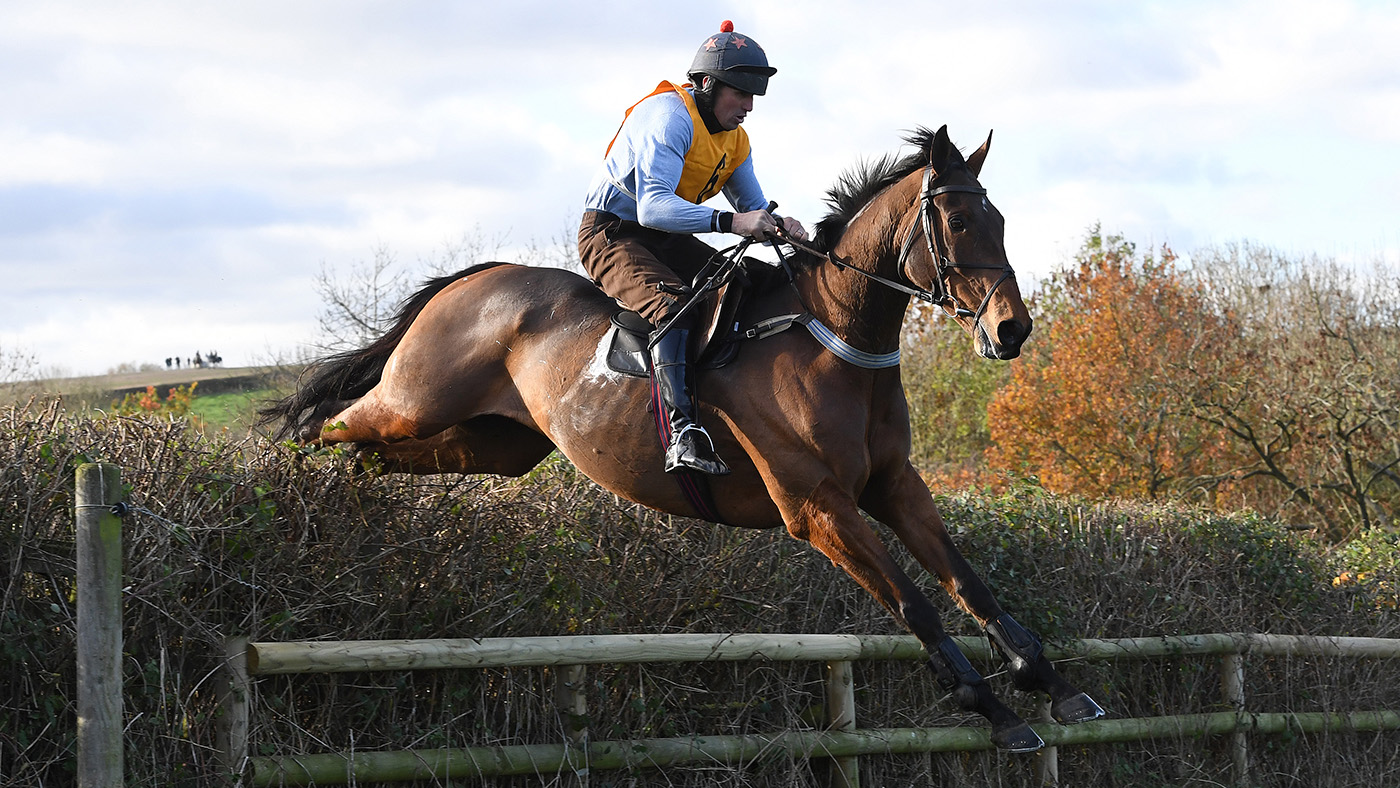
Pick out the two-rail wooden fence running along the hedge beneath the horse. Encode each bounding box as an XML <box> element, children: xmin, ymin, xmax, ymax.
<box><xmin>224</xmin><ymin>633</ymin><xmax>1400</xmax><ymax>785</ymax></box>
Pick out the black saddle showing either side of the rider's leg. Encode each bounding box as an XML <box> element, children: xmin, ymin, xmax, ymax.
<box><xmin>606</xmin><ymin>258</ymin><xmax>787</xmax><ymax>378</ymax></box>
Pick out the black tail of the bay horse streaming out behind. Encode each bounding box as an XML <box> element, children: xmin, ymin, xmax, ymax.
<box><xmin>258</xmin><ymin>263</ymin><xmax>505</xmax><ymax>441</ymax></box>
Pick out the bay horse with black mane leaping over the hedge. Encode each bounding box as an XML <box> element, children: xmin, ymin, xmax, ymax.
<box><xmin>263</xmin><ymin>126</ymin><xmax>1103</xmax><ymax>752</ymax></box>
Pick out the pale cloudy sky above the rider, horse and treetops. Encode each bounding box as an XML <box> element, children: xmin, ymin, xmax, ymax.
<box><xmin>0</xmin><ymin>0</ymin><xmax>1400</xmax><ymax>375</ymax></box>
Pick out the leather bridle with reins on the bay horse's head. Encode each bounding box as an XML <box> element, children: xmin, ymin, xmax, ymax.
<box><xmin>778</xmin><ymin>167</ymin><xmax>1016</xmax><ymax>321</ymax></box>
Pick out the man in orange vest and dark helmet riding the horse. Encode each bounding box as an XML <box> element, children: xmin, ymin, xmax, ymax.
<box><xmin>578</xmin><ymin>21</ymin><xmax>806</xmax><ymax>476</ymax></box>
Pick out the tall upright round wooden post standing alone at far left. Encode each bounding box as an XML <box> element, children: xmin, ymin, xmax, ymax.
<box><xmin>74</xmin><ymin>462</ymin><xmax>125</xmax><ymax>788</ymax></box>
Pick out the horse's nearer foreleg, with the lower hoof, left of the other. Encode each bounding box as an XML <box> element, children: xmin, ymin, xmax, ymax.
<box><xmin>783</xmin><ymin>481</ymin><xmax>1044</xmax><ymax>752</ymax></box>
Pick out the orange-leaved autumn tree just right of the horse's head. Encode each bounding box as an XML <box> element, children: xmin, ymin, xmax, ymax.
<box><xmin>988</xmin><ymin>228</ymin><xmax>1228</xmax><ymax>498</ymax></box>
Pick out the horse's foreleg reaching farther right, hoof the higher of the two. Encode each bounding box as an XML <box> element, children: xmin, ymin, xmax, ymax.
<box><xmin>862</xmin><ymin>467</ymin><xmax>1103</xmax><ymax>725</ymax></box>
